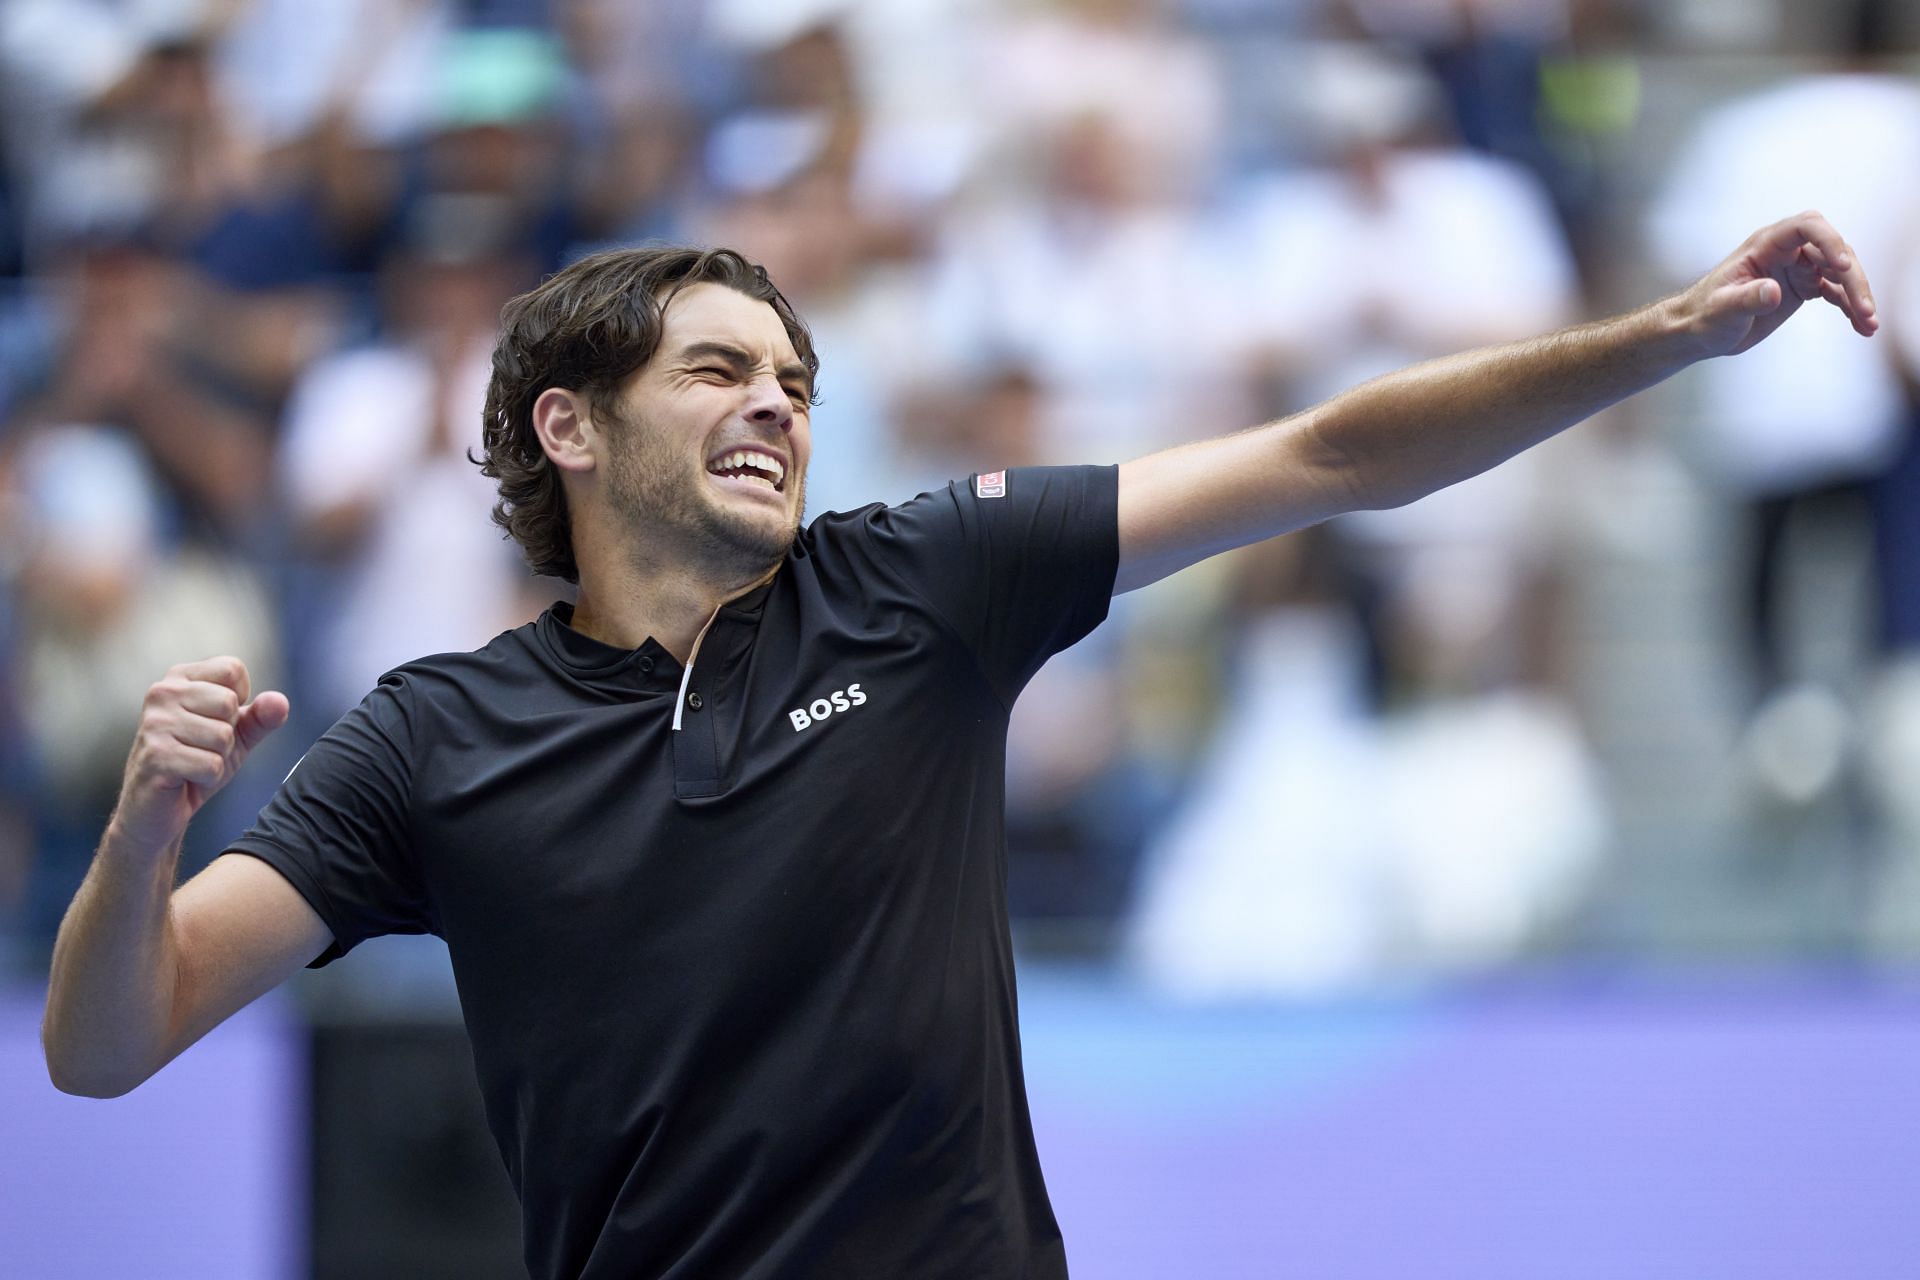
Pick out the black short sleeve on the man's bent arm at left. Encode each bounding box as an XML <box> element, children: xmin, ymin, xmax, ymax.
<box><xmin>227</xmin><ymin>676</ymin><xmax>434</xmax><ymax>969</ymax></box>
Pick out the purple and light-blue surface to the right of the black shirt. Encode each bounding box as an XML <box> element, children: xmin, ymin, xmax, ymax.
<box><xmin>1021</xmin><ymin>975</ymin><xmax>1920</xmax><ymax>1280</ymax></box>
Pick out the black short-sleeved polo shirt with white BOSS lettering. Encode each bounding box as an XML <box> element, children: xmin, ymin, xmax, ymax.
<box><xmin>232</xmin><ymin>468</ymin><xmax>1117</xmax><ymax>1280</ymax></box>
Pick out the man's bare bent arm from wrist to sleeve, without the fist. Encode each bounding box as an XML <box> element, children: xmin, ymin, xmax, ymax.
<box><xmin>40</xmin><ymin>827</ymin><xmax>332</xmax><ymax>1098</ymax></box>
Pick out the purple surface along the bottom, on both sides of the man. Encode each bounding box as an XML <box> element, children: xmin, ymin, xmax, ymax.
<box><xmin>0</xmin><ymin>965</ymin><xmax>1920</xmax><ymax>1280</ymax></box>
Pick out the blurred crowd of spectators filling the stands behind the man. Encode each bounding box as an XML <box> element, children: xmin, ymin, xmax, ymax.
<box><xmin>0</xmin><ymin>0</ymin><xmax>1920</xmax><ymax>996</ymax></box>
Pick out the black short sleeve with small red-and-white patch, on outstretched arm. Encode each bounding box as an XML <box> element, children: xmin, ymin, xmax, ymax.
<box><xmin>829</xmin><ymin>466</ymin><xmax>1119</xmax><ymax>706</ymax></box>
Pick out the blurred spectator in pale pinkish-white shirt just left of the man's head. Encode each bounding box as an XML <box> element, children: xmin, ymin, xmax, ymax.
<box><xmin>278</xmin><ymin>196</ymin><xmax>545</xmax><ymax>723</ymax></box>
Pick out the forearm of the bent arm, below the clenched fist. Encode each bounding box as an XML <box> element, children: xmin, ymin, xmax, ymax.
<box><xmin>40</xmin><ymin>825</ymin><xmax>180</xmax><ymax>1098</ymax></box>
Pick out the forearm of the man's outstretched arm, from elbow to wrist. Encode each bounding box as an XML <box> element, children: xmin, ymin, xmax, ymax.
<box><xmin>1306</xmin><ymin>299</ymin><xmax>1699</xmax><ymax>509</ymax></box>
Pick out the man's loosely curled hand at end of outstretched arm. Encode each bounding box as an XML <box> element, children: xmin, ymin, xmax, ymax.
<box><xmin>1672</xmin><ymin>211</ymin><xmax>1880</xmax><ymax>355</ymax></box>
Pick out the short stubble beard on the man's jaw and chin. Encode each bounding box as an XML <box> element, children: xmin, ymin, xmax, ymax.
<box><xmin>607</xmin><ymin>408</ymin><xmax>806</xmax><ymax>578</ymax></box>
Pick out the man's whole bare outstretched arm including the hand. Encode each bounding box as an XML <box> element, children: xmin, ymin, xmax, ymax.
<box><xmin>1114</xmin><ymin>213</ymin><xmax>1880</xmax><ymax>593</ymax></box>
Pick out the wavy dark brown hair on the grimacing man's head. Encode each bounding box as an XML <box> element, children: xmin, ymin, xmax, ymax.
<box><xmin>478</xmin><ymin>248</ymin><xmax>820</xmax><ymax>581</ymax></box>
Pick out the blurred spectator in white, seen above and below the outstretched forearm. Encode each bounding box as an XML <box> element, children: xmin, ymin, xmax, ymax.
<box><xmin>1135</xmin><ymin>46</ymin><xmax>1603</xmax><ymax>994</ymax></box>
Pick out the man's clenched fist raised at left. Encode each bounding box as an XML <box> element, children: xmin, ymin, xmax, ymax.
<box><xmin>109</xmin><ymin>658</ymin><xmax>290</xmax><ymax>854</ymax></box>
